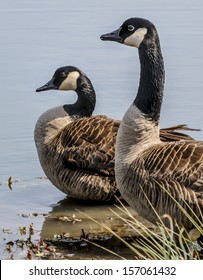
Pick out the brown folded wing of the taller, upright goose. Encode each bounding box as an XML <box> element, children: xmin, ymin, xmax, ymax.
<box><xmin>143</xmin><ymin>141</ymin><xmax>203</xmax><ymax>196</ymax></box>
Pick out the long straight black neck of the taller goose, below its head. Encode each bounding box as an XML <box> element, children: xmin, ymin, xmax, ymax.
<box><xmin>134</xmin><ymin>33</ymin><xmax>164</xmax><ymax>122</ymax></box>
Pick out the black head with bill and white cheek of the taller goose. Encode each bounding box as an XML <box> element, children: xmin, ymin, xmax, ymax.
<box><xmin>100</xmin><ymin>18</ymin><xmax>156</xmax><ymax>48</ymax></box>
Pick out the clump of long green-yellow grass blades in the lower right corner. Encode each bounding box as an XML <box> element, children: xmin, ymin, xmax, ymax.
<box><xmin>78</xmin><ymin>182</ymin><xmax>203</xmax><ymax>260</ymax></box>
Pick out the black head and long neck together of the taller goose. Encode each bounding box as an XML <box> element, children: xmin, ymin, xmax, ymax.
<box><xmin>100</xmin><ymin>18</ymin><xmax>165</xmax><ymax>125</ymax></box>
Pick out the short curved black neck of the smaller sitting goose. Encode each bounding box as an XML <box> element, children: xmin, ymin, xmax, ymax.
<box><xmin>64</xmin><ymin>75</ymin><xmax>96</xmax><ymax>117</ymax></box>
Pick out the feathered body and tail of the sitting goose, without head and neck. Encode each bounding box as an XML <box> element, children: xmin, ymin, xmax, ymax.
<box><xmin>35</xmin><ymin>110</ymin><xmax>197</xmax><ymax>201</ymax></box>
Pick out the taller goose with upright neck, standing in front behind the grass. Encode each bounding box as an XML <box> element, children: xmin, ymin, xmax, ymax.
<box><xmin>101</xmin><ymin>18</ymin><xmax>203</xmax><ymax>234</ymax></box>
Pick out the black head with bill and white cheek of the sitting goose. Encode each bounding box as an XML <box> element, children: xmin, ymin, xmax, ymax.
<box><xmin>36</xmin><ymin>66</ymin><xmax>83</xmax><ymax>92</ymax></box>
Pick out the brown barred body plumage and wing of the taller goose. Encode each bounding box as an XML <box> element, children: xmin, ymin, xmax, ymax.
<box><xmin>119</xmin><ymin>141</ymin><xmax>203</xmax><ymax>230</ymax></box>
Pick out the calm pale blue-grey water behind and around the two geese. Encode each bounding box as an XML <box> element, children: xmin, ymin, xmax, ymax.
<box><xmin>0</xmin><ymin>0</ymin><xmax>203</xmax><ymax>259</ymax></box>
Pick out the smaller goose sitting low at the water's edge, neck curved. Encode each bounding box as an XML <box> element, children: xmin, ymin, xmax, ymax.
<box><xmin>34</xmin><ymin>66</ymin><xmax>198</xmax><ymax>201</ymax></box>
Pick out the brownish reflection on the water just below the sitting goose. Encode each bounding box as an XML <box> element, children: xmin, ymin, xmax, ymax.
<box><xmin>41</xmin><ymin>198</ymin><xmax>151</xmax><ymax>239</ymax></box>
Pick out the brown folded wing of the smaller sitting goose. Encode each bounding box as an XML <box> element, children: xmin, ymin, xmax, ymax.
<box><xmin>61</xmin><ymin>116</ymin><xmax>119</xmax><ymax>176</ymax></box>
